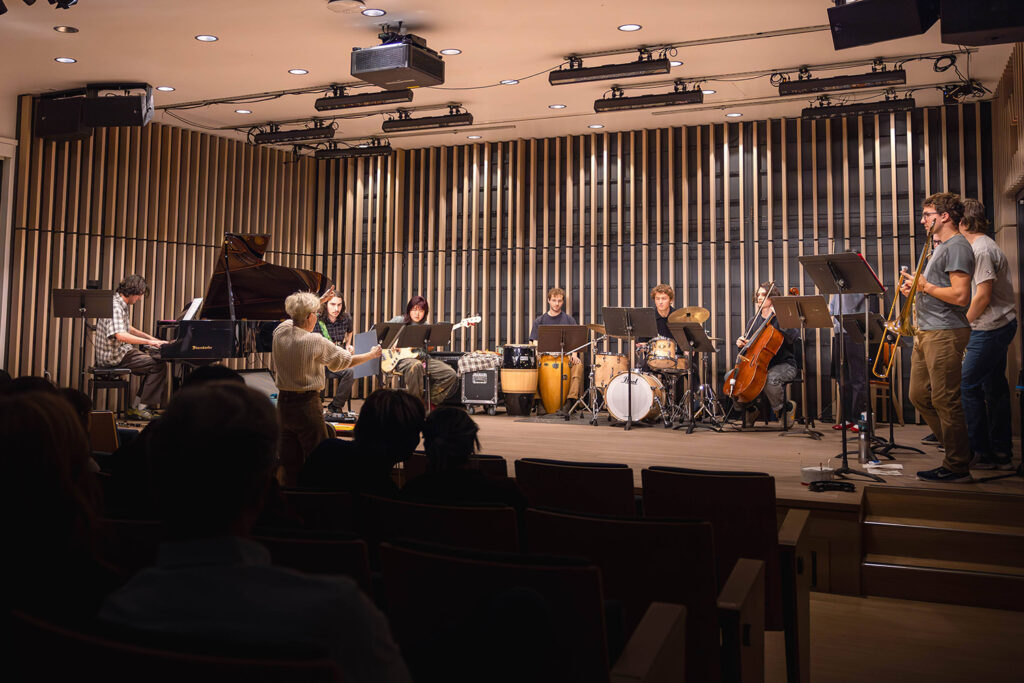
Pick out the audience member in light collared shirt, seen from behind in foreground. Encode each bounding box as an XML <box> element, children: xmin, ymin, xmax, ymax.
<box><xmin>100</xmin><ymin>382</ymin><xmax>409</xmax><ymax>681</ymax></box>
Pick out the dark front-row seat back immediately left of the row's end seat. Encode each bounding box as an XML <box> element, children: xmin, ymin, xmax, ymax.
<box><xmin>515</xmin><ymin>458</ymin><xmax>637</xmax><ymax>517</ymax></box>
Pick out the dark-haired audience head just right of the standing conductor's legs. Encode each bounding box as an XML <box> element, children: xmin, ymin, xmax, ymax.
<box><xmin>352</xmin><ymin>389</ymin><xmax>425</xmax><ymax>472</ymax></box>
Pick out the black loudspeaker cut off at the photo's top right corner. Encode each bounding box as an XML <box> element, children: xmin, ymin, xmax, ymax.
<box><xmin>942</xmin><ymin>0</ymin><xmax>1024</xmax><ymax>45</ymax></box>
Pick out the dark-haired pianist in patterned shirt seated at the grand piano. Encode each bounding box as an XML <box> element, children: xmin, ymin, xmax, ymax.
<box><xmin>92</xmin><ymin>275</ymin><xmax>167</xmax><ymax>420</ymax></box>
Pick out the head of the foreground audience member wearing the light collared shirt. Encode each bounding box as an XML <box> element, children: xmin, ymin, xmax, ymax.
<box><xmin>151</xmin><ymin>381</ymin><xmax>279</xmax><ymax>539</ymax></box>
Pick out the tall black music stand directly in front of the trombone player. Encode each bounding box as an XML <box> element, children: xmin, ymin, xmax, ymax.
<box><xmin>797</xmin><ymin>252</ymin><xmax>885</xmax><ymax>483</ymax></box>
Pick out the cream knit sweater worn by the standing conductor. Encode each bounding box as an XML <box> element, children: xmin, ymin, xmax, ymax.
<box><xmin>272</xmin><ymin>321</ymin><xmax>352</xmax><ymax>391</ymax></box>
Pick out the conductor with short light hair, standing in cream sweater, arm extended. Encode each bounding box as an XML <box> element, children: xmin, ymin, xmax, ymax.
<box><xmin>272</xmin><ymin>292</ymin><xmax>381</xmax><ymax>486</ymax></box>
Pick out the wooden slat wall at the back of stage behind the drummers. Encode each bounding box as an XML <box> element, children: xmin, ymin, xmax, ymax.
<box><xmin>315</xmin><ymin>103</ymin><xmax>992</xmax><ymax>414</ymax></box>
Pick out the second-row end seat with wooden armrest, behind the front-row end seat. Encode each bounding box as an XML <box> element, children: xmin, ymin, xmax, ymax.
<box><xmin>524</xmin><ymin>509</ymin><xmax>764</xmax><ymax>681</ymax></box>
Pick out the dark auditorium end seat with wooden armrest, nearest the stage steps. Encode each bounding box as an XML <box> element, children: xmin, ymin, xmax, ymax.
<box><xmin>641</xmin><ymin>467</ymin><xmax>810</xmax><ymax>683</ymax></box>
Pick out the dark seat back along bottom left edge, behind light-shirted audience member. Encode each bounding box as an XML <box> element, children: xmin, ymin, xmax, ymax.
<box><xmin>9</xmin><ymin>611</ymin><xmax>341</xmax><ymax>683</ymax></box>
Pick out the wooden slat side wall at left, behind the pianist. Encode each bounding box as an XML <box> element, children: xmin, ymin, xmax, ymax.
<box><xmin>4</xmin><ymin>97</ymin><xmax>315</xmax><ymax>395</ymax></box>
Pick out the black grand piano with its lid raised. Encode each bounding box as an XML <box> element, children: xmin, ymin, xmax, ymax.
<box><xmin>157</xmin><ymin>232</ymin><xmax>334</xmax><ymax>365</ymax></box>
